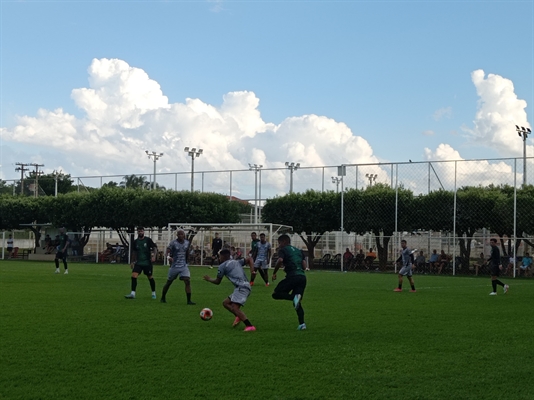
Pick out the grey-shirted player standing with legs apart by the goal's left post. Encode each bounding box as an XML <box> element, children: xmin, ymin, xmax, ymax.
<box><xmin>160</xmin><ymin>229</ymin><xmax>196</xmax><ymax>306</ymax></box>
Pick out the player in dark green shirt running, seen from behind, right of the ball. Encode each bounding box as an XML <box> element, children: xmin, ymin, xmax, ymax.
<box><xmin>272</xmin><ymin>235</ymin><xmax>307</xmax><ymax>331</ymax></box>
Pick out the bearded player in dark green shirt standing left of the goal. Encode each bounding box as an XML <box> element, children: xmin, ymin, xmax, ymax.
<box><xmin>124</xmin><ymin>226</ymin><xmax>158</xmax><ymax>299</ymax></box>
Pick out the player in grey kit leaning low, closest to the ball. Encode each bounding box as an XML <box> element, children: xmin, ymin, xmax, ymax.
<box><xmin>204</xmin><ymin>249</ymin><xmax>256</xmax><ymax>332</ymax></box>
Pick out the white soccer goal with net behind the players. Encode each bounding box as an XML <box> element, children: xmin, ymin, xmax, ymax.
<box><xmin>165</xmin><ymin>222</ymin><xmax>293</xmax><ymax>265</ymax></box>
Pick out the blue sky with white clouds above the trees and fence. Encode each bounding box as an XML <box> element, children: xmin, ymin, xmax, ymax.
<box><xmin>0</xmin><ymin>0</ymin><xmax>534</xmax><ymax>195</ymax></box>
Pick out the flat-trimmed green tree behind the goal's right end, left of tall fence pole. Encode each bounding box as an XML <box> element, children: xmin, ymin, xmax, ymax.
<box><xmin>262</xmin><ymin>190</ymin><xmax>341</xmax><ymax>264</ymax></box>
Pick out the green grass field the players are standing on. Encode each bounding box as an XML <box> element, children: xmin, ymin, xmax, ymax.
<box><xmin>0</xmin><ymin>261</ymin><xmax>534</xmax><ymax>399</ymax></box>
